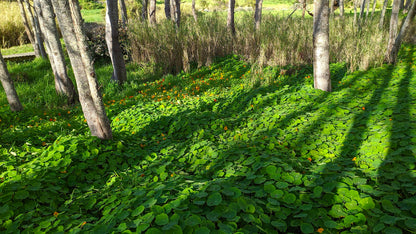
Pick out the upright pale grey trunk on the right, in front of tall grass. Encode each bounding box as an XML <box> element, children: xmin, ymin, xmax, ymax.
<box><xmin>313</xmin><ymin>0</ymin><xmax>331</xmax><ymax>92</ymax></box>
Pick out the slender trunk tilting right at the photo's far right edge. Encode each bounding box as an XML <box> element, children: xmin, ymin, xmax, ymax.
<box><xmin>387</xmin><ymin>1</ymin><xmax>416</xmax><ymax>64</ymax></box>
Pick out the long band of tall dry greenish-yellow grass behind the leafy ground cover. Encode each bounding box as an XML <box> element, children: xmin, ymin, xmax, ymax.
<box><xmin>129</xmin><ymin>12</ymin><xmax>388</xmax><ymax>72</ymax></box>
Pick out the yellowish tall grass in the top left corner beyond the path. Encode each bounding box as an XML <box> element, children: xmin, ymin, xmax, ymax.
<box><xmin>0</xmin><ymin>1</ymin><xmax>28</xmax><ymax>48</ymax></box>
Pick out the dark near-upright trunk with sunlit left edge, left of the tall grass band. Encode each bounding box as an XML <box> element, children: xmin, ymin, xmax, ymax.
<box><xmin>105</xmin><ymin>0</ymin><xmax>127</xmax><ymax>84</ymax></box>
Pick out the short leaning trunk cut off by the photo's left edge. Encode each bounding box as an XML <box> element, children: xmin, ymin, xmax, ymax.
<box><xmin>0</xmin><ymin>52</ymin><xmax>23</xmax><ymax>111</ymax></box>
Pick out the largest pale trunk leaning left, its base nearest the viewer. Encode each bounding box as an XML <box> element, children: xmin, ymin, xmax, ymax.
<box><xmin>52</xmin><ymin>0</ymin><xmax>112</xmax><ymax>139</ymax></box>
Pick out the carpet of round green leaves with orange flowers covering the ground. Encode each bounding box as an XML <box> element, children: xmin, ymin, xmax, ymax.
<box><xmin>0</xmin><ymin>46</ymin><xmax>416</xmax><ymax>233</ymax></box>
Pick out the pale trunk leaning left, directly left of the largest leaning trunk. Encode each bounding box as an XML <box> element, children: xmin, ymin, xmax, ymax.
<box><xmin>33</xmin><ymin>0</ymin><xmax>76</xmax><ymax>104</ymax></box>
